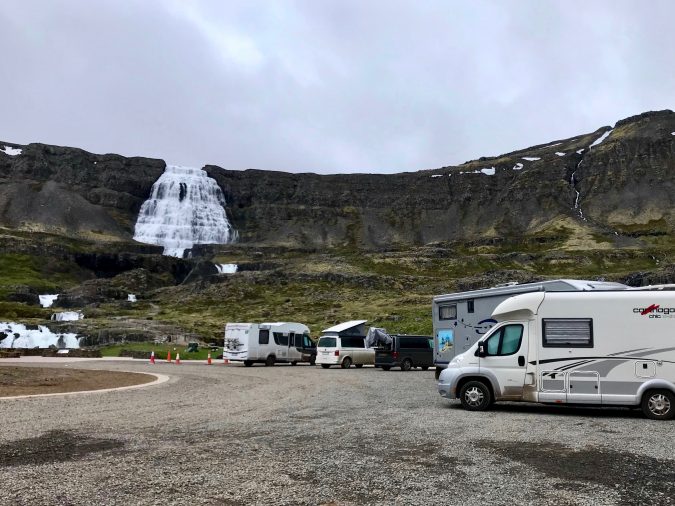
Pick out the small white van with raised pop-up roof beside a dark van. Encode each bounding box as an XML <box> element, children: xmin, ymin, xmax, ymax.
<box><xmin>316</xmin><ymin>320</ymin><xmax>375</xmax><ymax>369</ymax></box>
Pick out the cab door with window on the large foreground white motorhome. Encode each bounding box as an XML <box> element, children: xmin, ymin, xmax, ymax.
<box><xmin>479</xmin><ymin>323</ymin><xmax>528</xmax><ymax>400</ymax></box>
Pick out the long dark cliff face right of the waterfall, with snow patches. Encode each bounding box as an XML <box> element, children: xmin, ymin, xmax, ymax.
<box><xmin>206</xmin><ymin>111</ymin><xmax>675</xmax><ymax>247</ymax></box>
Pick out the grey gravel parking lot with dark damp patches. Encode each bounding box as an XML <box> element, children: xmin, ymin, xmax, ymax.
<box><xmin>0</xmin><ymin>361</ymin><xmax>675</xmax><ymax>505</ymax></box>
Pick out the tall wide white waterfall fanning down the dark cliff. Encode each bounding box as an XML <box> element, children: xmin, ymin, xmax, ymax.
<box><xmin>134</xmin><ymin>165</ymin><xmax>237</xmax><ymax>258</ymax></box>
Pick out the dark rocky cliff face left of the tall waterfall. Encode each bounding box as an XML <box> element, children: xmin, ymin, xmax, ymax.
<box><xmin>0</xmin><ymin>142</ymin><xmax>165</xmax><ymax>240</ymax></box>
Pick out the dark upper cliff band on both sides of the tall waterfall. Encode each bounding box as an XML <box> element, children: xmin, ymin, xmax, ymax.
<box><xmin>0</xmin><ymin>111</ymin><xmax>675</xmax><ymax>247</ymax></box>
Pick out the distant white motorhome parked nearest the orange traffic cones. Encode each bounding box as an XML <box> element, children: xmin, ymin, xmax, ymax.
<box><xmin>223</xmin><ymin>322</ymin><xmax>313</xmax><ymax>367</ymax></box>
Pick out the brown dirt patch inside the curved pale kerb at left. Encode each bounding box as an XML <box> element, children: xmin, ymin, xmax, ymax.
<box><xmin>0</xmin><ymin>366</ymin><xmax>156</xmax><ymax>397</ymax></box>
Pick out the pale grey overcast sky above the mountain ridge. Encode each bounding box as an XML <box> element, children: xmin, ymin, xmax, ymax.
<box><xmin>0</xmin><ymin>0</ymin><xmax>675</xmax><ymax>173</ymax></box>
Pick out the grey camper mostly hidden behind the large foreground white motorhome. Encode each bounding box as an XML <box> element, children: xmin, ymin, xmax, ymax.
<box><xmin>432</xmin><ymin>279</ymin><xmax>628</xmax><ymax>379</ymax></box>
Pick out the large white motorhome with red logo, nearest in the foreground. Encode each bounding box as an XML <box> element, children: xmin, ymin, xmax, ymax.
<box><xmin>438</xmin><ymin>287</ymin><xmax>675</xmax><ymax>419</ymax></box>
